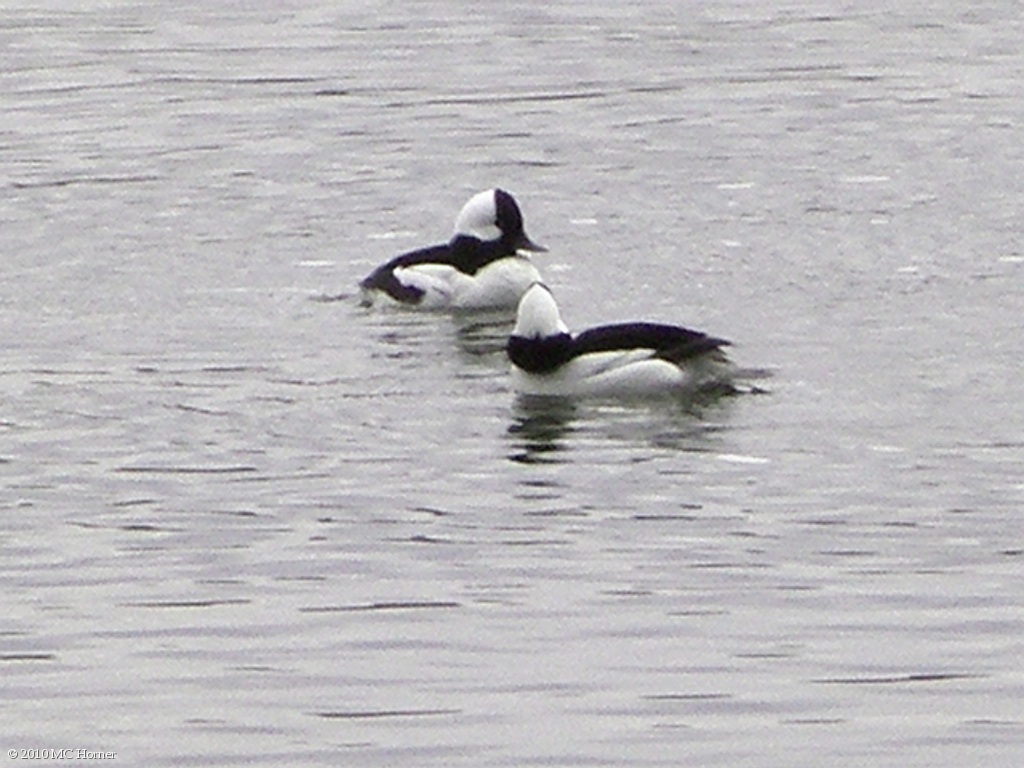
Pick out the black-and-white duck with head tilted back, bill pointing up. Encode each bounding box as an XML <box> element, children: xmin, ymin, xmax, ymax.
<box><xmin>506</xmin><ymin>283</ymin><xmax>734</xmax><ymax>397</ymax></box>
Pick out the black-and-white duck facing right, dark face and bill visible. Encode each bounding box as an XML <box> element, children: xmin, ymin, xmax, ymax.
<box><xmin>359</xmin><ymin>189</ymin><xmax>547</xmax><ymax>310</ymax></box>
